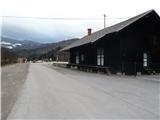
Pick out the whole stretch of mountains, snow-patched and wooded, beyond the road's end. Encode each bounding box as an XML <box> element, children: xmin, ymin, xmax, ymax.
<box><xmin>1</xmin><ymin>37</ymin><xmax>79</xmax><ymax>60</ymax></box>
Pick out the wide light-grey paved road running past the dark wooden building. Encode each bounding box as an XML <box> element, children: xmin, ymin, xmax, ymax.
<box><xmin>8</xmin><ymin>63</ymin><xmax>160</xmax><ymax>119</ymax></box>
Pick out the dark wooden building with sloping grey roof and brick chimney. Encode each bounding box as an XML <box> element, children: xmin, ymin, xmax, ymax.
<box><xmin>63</xmin><ymin>10</ymin><xmax>160</xmax><ymax>74</ymax></box>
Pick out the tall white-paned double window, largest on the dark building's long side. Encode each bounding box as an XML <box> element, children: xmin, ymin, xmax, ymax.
<box><xmin>97</xmin><ymin>48</ymin><xmax>104</xmax><ymax>66</ymax></box>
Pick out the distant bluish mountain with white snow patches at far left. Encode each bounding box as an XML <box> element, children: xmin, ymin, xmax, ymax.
<box><xmin>1</xmin><ymin>37</ymin><xmax>41</xmax><ymax>51</ymax></box>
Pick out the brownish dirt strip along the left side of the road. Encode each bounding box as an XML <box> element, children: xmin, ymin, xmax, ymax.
<box><xmin>1</xmin><ymin>63</ymin><xmax>29</xmax><ymax>120</ymax></box>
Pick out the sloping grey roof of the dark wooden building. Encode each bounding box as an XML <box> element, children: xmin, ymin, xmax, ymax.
<box><xmin>61</xmin><ymin>10</ymin><xmax>157</xmax><ymax>51</ymax></box>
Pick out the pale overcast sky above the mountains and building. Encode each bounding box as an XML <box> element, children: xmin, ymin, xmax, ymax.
<box><xmin>0</xmin><ymin>0</ymin><xmax>160</xmax><ymax>42</ymax></box>
